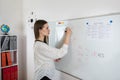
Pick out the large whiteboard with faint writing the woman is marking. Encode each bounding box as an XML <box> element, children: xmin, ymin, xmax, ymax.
<box><xmin>49</xmin><ymin>14</ymin><xmax>120</xmax><ymax>80</ymax></box>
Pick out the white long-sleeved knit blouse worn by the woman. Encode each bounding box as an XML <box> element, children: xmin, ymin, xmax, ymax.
<box><xmin>34</xmin><ymin>41</ymin><xmax>68</xmax><ymax>80</ymax></box>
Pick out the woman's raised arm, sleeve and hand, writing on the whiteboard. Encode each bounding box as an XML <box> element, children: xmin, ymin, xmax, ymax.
<box><xmin>35</xmin><ymin>28</ymin><xmax>71</xmax><ymax>59</ymax></box>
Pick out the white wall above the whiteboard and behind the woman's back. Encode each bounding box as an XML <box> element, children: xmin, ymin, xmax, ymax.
<box><xmin>23</xmin><ymin>0</ymin><xmax>120</xmax><ymax>80</ymax></box>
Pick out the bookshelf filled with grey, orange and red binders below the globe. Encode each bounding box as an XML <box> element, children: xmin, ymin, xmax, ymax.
<box><xmin>0</xmin><ymin>35</ymin><xmax>18</xmax><ymax>80</ymax></box>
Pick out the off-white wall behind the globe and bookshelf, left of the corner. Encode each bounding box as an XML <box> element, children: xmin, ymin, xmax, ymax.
<box><xmin>0</xmin><ymin>0</ymin><xmax>24</xmax><ymax>80</ymax></box>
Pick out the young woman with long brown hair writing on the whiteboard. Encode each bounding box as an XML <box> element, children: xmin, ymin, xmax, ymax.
<box><xmin>34</xmin><ymin>20</ymin><xmax>71</xmax><ymax>80</ymax></box>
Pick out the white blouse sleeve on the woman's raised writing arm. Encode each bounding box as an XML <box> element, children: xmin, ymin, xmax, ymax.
<box><xmin>37</xmin><ymin>43</ymin><xmax>68</xmax><ymax>59</ymax></box>
